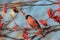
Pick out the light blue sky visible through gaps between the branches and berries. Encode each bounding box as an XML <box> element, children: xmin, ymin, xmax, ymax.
<box><xmin>0</xmin><ymin>0</ymin><xmax>60</xmax><ymax>40</ymax></box>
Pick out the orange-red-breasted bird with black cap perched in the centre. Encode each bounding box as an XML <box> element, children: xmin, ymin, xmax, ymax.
<box><xmin>26</xmin><ymin>15</ymin><xmax>41</xmax><ymax>29</ymax></box>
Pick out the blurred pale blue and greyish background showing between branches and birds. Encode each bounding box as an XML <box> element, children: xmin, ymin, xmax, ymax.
<box><xmin>0</xmin><ymin>0</ymin><xmax>60</xmax><ymax>40</ymax></box>
